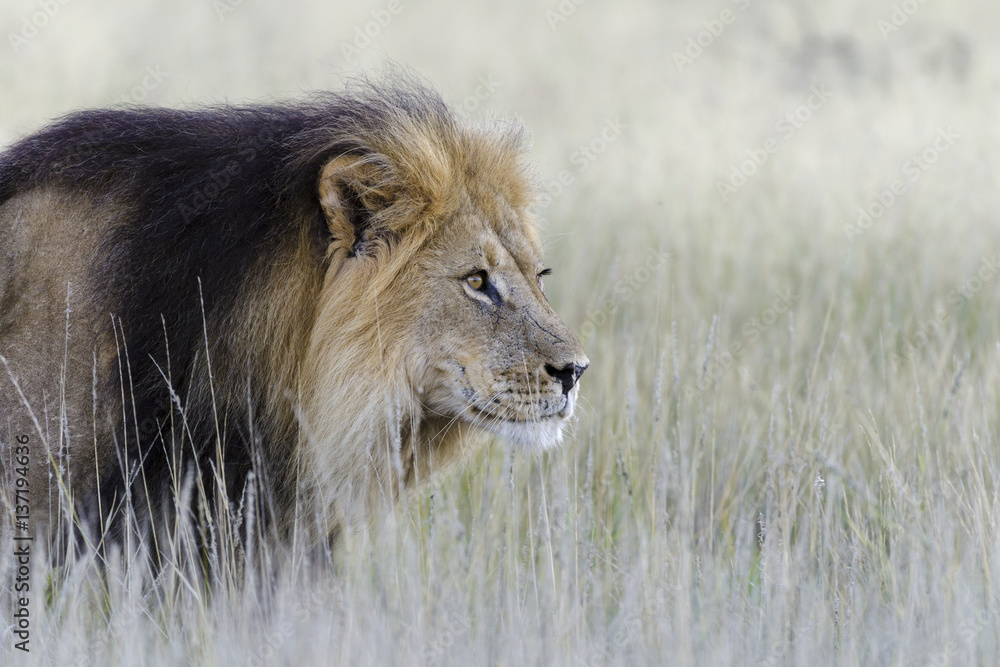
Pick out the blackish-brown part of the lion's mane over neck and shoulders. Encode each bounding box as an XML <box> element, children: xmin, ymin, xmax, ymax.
<box><xmin>0</xmin><ymin>83</ymin><xmax>454</xmax><ymax>544</ymax></box>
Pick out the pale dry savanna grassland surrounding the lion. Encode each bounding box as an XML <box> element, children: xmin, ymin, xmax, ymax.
<box><xmin>0</xmin><ymin>0</ymin><xmax>1000</xmax><ymax>666</ymax></box>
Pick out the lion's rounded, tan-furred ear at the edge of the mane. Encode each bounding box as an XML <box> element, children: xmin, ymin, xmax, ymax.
<box><xmin>319</xmin><ymin>155</ymin><xmax>393</xmax><ymax>255</ymax></box>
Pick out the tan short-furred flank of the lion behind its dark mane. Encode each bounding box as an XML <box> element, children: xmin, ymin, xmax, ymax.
<box><xmin>0</xmin><ymin>188</ymin><xmax>117</xmax><ymax>515</ymax></box>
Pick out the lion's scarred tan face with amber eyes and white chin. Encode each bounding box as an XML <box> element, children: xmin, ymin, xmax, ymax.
<box><xmin>418</xmin><ymin>202</ymin><xmax>589</xmax><ymax>449</ymax></box>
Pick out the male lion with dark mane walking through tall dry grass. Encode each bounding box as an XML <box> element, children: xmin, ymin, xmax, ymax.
<box><xmin>0</xmin><ymin>82</ymin><xmax>588</xmax><ymax>548</ymax></box>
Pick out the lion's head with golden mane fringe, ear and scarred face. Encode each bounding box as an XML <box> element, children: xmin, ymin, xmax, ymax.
<box><xmin>306</xmin><ymin>86</ymin><xmax>589</xmax><ymax>520</ymax></box>
